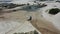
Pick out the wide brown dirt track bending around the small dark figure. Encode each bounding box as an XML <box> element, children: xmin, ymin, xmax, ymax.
<box><xmin>0</xmin><ymin>11</ymin><xmax>60</xmax><ymax>34</ymax></box>
